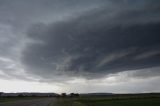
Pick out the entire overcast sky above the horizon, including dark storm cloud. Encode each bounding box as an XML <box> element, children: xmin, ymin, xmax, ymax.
<box><xmin>0</xmin><ymin>0</ymin><xmax>160</xmax><ymax>93</ymax></box>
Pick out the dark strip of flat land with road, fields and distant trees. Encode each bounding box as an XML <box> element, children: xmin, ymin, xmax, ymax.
<box><xmin>0</xmin><ymin>93</ymin><xmax>160</xmax><ymax>106</ymax></box>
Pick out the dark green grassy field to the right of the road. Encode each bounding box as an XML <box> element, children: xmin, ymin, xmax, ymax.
<box><xmin>52</xmin><ymin>95</ymin><xmax>160</xmax><ymax>106</ymax></box>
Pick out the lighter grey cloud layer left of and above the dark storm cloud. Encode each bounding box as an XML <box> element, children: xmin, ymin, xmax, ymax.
<box><xmin>0</xmin><ymin>0</ymin><xmax>106</xmax><ymax>79</ymax></box>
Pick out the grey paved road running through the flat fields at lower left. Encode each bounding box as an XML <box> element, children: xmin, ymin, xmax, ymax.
<box><xmin>0</xmin><ymin>98</ymin><xmax>54</xmax><ymax>106</ymax></box>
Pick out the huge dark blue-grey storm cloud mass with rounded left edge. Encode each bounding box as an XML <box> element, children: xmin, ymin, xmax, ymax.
<box><xmin>22</xmin><ymin>0</ymin><xmax>160</xmax><ymax>78</ymax></box>
